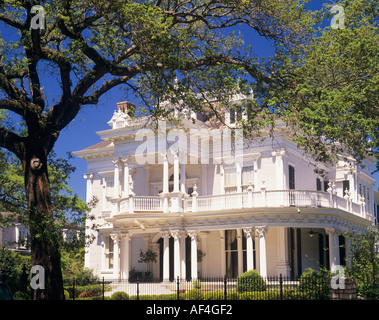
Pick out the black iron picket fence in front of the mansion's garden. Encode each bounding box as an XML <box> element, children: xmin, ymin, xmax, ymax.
<box><xmin>66</xmin><ymin>275</ymin><xmax>329</xmax><ymax>300</ymax></box>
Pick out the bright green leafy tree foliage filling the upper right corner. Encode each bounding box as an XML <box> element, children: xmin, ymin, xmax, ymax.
<box><xmin>255</xmin><ymin>0</ymin><xmax>379</xmax><ymax>170</ymax></box>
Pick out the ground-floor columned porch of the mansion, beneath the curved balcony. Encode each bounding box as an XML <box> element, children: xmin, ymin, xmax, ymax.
<box><xmin>101</xmin><ymin>227</ymin><xmax>349</xmax><ymax>282</ymax></box>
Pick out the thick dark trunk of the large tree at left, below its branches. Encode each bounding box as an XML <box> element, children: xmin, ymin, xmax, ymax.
<box><xmin>23</xmin><ymin>147</ymin><xmax>64</xmax><ymax>300</ymax></box>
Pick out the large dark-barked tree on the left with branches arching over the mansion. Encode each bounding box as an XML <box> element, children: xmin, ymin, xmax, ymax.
<box><xmin>0</xmin><ymin>0</ymin><xmax>378</xmax><ymax>299</ymax></box>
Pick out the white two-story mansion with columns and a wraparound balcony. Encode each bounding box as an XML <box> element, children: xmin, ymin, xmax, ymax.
<box><xmin>75</xmin><ymin>102</ymin><xmax>378</xmax><ymax>281</ymax></box>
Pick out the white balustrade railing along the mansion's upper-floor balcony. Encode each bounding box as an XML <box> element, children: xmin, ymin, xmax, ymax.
<box><xmin>110</xmin><ymin>189</ymin><xmax>372</xmax><ymax>220</ymax></box>
